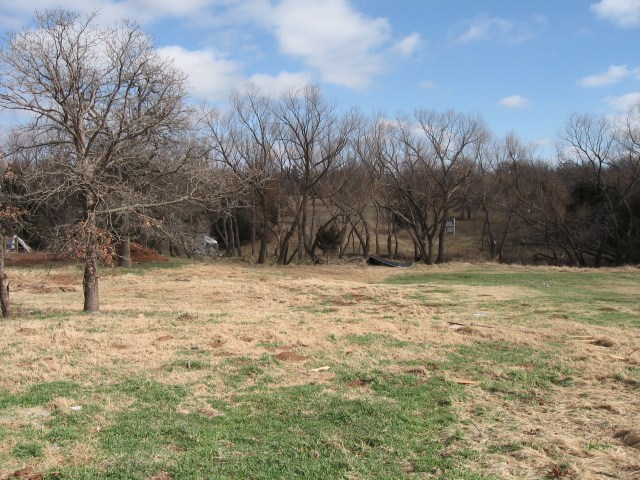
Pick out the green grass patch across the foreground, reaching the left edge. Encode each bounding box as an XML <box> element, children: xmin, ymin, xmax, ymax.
<box><xmin>0</xmin><ymin>376</ymin><xmax>484</xmax><ymax>480</ymax></box>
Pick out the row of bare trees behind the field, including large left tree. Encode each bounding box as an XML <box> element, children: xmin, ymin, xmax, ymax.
<box><xmin>0</xmin><ymin>10</ymin><xmax>640</xmax><ymax>315</ymax></box>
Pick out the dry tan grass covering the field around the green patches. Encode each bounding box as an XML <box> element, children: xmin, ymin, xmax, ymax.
<box><xmin>0</xmin><ymin>262</ymin><xmax>640</xmax><ymax>479</ymax></box>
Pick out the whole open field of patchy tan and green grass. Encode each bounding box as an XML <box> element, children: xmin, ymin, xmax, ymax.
<box><xmin>0</xmin><ymin>261</ymin><xmax>640</xmax><ymax>480</ymax></box>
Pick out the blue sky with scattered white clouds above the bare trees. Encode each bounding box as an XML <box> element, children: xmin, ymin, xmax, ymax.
<box><xmin>0</xmin><ymin>0</ymin><xmax>640</xmax><ymax>156</ymax></box>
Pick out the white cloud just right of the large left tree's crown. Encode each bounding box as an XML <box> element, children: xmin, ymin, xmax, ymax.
<box><xmin>158</xmin><ymin>45</ymin><xmax>243</xmax><ymax>100</ymax></box>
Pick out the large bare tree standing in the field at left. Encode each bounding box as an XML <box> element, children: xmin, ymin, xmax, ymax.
<box><xmin>0</xmin><ymin>10</ymin><xmax>196</xmax><ymax>311</ymax></box>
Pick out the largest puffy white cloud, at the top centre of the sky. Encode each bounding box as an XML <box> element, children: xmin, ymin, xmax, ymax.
<box><xmin>269</xmin><ymin>0</ymin><xmax>391</xmax><ymax>88</ymax></box>
